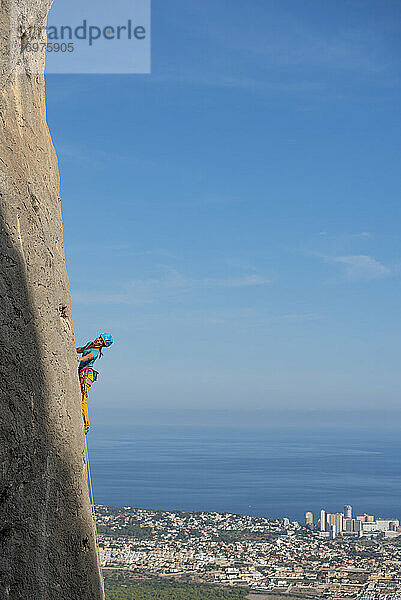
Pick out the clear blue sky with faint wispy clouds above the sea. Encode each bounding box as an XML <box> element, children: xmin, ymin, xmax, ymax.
<box><xmin>47</xmin><ymin>0</ymin><xmax>401</xmax><ymax>422</ymax></box>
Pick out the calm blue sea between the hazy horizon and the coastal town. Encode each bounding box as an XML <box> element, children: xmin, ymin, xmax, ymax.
<box><xmin>88</xmin><ymin>426</ymin><xmax>401</xmax><ymax>521</ymax></box>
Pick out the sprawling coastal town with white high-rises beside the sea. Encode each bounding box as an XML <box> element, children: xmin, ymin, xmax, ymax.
<box><xmin>96</xmin><ymin>505</ymin><xmax>401</xmax><ymax>600</ymax></box>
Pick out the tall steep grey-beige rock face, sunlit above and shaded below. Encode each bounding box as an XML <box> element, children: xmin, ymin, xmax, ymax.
<box><xmin>0</xmin><ymin>0</ymin><xmax>103</xmax><ymax>600</ymax></box>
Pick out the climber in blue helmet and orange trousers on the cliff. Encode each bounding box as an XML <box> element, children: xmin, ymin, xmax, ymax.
<box><xmin>77</xmin><ymin>333</ymin><xmax>114</xmax><ymax>435</ymax></box>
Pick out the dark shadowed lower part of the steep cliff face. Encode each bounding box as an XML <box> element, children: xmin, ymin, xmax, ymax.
<box><xmin>0</xmin><ymin>199</ymin><xmax>103</xmax><ymax>600</ymax></box>
